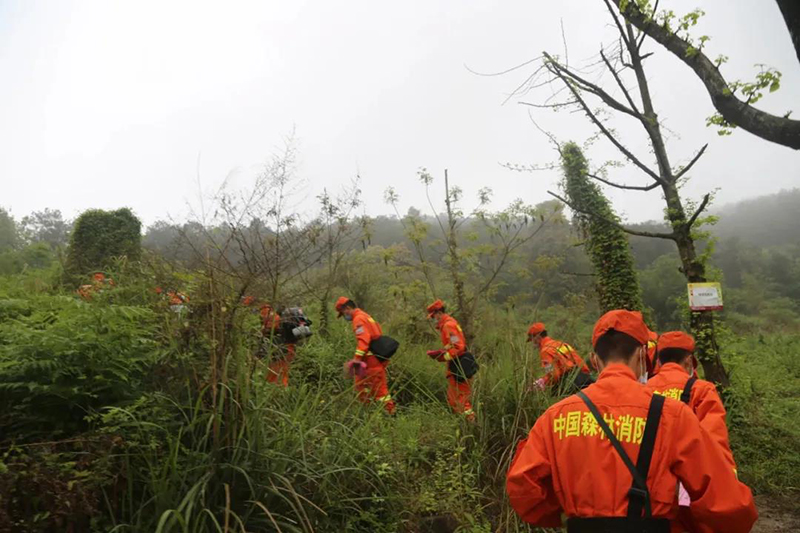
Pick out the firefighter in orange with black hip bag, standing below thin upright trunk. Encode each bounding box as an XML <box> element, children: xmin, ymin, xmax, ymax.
<box><xmin>427</xmin><ymin>300</ymin><xmax>475</xmax><ymax>422</ymax></box>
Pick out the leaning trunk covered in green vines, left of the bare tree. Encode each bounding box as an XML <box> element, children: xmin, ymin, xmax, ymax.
<box><xmin>560</xmin><ymin>142</ymin><xmax>643</xmax><ymax>312</ymax></box>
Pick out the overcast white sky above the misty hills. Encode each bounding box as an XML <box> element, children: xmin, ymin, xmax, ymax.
<box><xmin>0</xmin><ymin>0</ymin><xmax>800</xmax><ymax>224</ymax></box>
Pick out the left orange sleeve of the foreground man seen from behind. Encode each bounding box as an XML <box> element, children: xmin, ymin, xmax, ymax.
<box><xmin>506</xmin><ymin>414</ymin><xmax>562</xmax><ymax>527</ymax></box>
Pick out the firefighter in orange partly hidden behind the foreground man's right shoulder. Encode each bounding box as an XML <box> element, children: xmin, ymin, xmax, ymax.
<box><xmin>647</xmin><ymin>331</ymin><xmax>736</xmax><ymax>533</ymax></box>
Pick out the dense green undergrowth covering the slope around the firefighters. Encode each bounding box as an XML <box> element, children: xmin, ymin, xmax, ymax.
<box><xmin>0</xmin><ymin>268</ymin><xmax>800</xmax><ymax>532</ymax></box>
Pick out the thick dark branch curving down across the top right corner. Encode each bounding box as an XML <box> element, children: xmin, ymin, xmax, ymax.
<box><xmin>611</xmin><ymin>0</ymin><xmax>800</xmax><ymax>150</ymax></box>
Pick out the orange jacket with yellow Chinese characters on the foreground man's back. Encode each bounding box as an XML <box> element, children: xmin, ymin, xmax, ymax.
<box><xmin>506</xmin><ymin>364</ymin><xmax>757</xmax><ymax>533</ymax></box>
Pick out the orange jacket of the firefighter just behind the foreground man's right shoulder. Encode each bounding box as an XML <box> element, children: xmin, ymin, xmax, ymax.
<box><xmin>647</xmin><ymin>363</ymin><xmax>736</xmax><ymax>468</ymax></box>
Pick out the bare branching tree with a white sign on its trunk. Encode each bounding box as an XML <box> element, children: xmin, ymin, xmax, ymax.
<box><xmin>516</xmin><ymin>0</ymin><xmax>729</xmax><ymax>385</ymax></box>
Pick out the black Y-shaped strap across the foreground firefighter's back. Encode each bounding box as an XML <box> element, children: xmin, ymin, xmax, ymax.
<box><xmin>578</xmin><ymin>391</ymin><xmax>664</xmax><ymax>518</ymax></box>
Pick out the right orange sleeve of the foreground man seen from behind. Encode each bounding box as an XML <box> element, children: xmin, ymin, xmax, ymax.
<box><xmin>667</xmin><ymin>400</ymin><xmax>758</xmax><ymax>533</ymax></box>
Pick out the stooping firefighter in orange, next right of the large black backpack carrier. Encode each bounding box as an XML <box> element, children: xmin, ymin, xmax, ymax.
<box><xmin>335</xmin><ymin>296</ymin><xmax>396</xmax><ymax>415</ymax></box>
